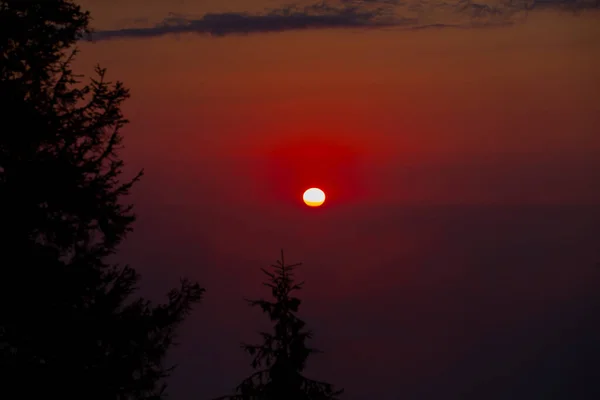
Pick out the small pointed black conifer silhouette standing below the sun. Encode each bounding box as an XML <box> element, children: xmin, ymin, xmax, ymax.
<box><xmin>220</xmin><ymin>250</ymin><xmax>343</xmax><ymax>400</ymax></box>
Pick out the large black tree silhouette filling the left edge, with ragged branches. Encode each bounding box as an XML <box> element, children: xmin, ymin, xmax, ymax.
<box><xmin>0</xmin><ymin>0</ymin><xmax>203</xmax><ymax>400</ymax></box>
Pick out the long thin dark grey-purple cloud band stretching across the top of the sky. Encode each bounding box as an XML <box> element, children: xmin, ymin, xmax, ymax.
<box><xmin>91</xmin><ymin>0</ymin><xmax>600</xmax><ymax>40</ymax></box>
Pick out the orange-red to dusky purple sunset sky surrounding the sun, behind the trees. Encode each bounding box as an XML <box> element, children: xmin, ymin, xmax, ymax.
<box><xmin>71</xmin><ymin>0</ymin><xmax>600</xmax><ymax>400</ymax></box>
